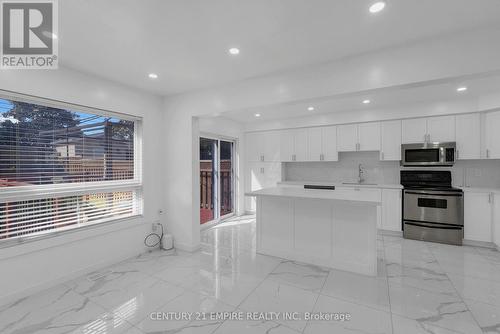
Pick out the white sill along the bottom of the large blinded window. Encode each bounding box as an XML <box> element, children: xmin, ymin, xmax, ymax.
<box><xmin>0</xmin><ymin>215</ymin><xmax>144</xmax><ymax>260</ymax></box>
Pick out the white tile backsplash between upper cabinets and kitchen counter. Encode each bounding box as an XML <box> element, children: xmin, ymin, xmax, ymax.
<box><xmin>283</xmin><ymin>152</ymin><xmax>500</xmax><ymax>188</ymax></box>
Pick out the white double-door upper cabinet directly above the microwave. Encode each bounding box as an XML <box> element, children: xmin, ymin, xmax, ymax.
<box><xmin>402</xmin><ymin>116</ymin><xmax>455</xmax><ymax>144</ymax></box>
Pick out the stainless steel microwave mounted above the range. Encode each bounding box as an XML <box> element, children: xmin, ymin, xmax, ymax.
<box><xmin>401</xmin><ymin>142</ymin><xmax>457</xmax><ymax>166</ymax></box>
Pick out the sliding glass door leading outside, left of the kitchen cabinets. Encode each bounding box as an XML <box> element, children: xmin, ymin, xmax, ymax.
<box><xmin>200</xmin><ymin>138</ymin><xmax>234</xmax><ymax>224</ymax></box>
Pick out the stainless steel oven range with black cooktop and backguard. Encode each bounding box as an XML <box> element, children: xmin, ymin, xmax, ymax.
<box><xmin>401</xmin><ymin>170</ymin><xmax>464</xmax><ymax>245</ymax></box>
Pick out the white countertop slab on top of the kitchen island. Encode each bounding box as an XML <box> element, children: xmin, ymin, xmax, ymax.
<box><xmin>245</xmin><ymin>186</ymin><xmax>381</xmax><ymax>205</ymax></box>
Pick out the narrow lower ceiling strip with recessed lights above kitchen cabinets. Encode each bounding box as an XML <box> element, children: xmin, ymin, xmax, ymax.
<box><xmin>219</xmin><ymin>74</ymin><xmax>500</xmax><ymax>123</ymax></box>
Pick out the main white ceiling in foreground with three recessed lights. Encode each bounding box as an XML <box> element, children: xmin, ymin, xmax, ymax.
<box><xmin>59</xmin><ymin>0</ymin><xmax>500</xmax><ymax>95</ymax></box>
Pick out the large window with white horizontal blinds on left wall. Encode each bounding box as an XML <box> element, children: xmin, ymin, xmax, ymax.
<box><xmin>0</xmin><ymin>92</ymin><xmax>142</xmax><ymax>241</ymax></box>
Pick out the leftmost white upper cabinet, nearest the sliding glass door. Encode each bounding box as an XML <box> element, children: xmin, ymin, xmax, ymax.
<box><xmin>245</xmin><ymin>131</ymin><xmax>280</xmax><ymax>162</ymax></box>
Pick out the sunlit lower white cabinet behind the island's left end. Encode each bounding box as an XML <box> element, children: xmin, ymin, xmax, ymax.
<box><xmin>245</xmin><ymin>162</ymin><xmax>281</xmax><ymax>211</ymax></box>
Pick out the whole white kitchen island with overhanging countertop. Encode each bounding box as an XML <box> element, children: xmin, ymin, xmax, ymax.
<box><xmin>246</xmin><ymin>187</ymin><xmax>381</xmax><ymax>276</ymax></box>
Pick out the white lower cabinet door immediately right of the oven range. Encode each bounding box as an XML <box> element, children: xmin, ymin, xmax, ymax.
<box><xmin>464</xmin><ymin>191</ymin><xmax>492</xmax><ymax>242</ymax></box>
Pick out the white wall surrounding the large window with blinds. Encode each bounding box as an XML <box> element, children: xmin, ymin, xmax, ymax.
<box><xmin>0</xmin><ymin>69</ymin><xmax>164</xmax><ymax>301</ymax></box>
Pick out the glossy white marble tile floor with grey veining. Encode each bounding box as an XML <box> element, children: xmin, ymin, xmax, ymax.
<box><xmin>0</xmin><ymin>216</ymin><xmax>500</xmax><ymax>334</ymax></box>
